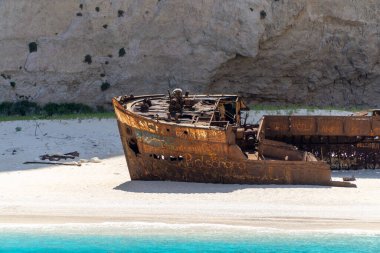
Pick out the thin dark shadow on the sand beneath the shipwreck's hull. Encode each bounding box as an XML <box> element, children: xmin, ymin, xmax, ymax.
<box><xmin>114</xmin><ymin>181</ymin><xmax>330</xmax><ymax>194</ymax></box>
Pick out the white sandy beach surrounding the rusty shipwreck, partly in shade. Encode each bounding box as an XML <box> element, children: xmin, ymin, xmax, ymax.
<box><xmin>0</xmin><ymin>119</ymin><xmax>380</xmax><ymax>232</ymax></box>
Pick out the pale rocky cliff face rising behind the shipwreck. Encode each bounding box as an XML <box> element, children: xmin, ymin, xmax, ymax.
<box><xmin>0</xmin><ymin>0</ymin><xmax>380</xmax><ymax>106</ymax></box>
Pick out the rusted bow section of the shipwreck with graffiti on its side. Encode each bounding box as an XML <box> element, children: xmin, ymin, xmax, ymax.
<box><xmin>113</xmin><ymin>92</ymin><xmax>354</xmax><ymax>186</ymax></box>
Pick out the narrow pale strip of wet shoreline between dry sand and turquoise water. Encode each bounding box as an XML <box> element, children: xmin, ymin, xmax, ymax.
<box><xmin>0</xmin><ymin>216</ymin><xmax>380</xmax><ymax>235</ymax></box>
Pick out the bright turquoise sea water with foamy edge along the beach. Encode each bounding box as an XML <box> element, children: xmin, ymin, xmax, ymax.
<box><xmin>0</xmin><ymin>223</ymin><xmax>380</xmax><ymax>253</ymax></box>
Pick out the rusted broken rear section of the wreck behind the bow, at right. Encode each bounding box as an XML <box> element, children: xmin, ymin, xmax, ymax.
<box><xmin>261</xmin><ymin>113</ymin><xmax>380</xmax><ymax>169</ymax></box>
